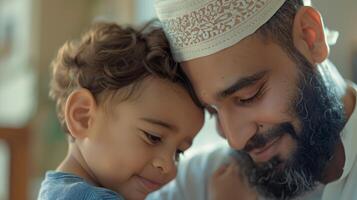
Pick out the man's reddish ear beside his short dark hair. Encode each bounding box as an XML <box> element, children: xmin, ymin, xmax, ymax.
<box><xmin>293</xmin><ymin>6</ymin><xmax>329</xmax><ymax>64</ymax></box>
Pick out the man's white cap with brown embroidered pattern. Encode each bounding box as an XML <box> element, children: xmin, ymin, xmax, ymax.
<box><xmin>155</xmin><ymin>0</ymin><xmax>285</xmax><ymax>62</ymax></box>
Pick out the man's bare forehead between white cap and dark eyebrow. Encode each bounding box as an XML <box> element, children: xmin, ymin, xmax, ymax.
<box><xmin>181</xmin><ymin>45</ymin><xmax>268</xmax><ymax>80</ymax></box>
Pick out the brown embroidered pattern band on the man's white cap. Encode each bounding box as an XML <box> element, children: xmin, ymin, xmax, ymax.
<box><xmin>162</xmin><ymin>0</ymin><xmax>269</xmax><ymax>48</ymax></box>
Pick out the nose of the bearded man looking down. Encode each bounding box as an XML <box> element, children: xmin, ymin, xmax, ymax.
<box><xmin>217</xmin><ymin>110</ymin><xmax>257</xmax><ymax>150</ymax></box>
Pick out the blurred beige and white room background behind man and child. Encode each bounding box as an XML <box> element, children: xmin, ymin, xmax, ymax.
<box><xmin>0</xmin><ymin>0</ymin><xmax>357</xmax><ymax>200</ymax></box>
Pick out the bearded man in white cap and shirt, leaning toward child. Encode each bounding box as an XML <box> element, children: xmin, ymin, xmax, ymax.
<box><xmin>146</xmin><ymin>0</ymin><xmax>357</xmax><ymax>200</ymax></box>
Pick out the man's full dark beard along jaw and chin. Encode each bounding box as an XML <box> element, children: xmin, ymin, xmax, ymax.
<box><xmin>234</xmin><ymin>55</ymin><xmax>346</xmax><ymax>199</ymax></box>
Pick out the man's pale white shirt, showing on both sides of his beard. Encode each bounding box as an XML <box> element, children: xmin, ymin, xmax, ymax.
<box><xmin>148</xmin><ymin>82</ymin><xmax>357</xmax><ymax>200</ymax></box>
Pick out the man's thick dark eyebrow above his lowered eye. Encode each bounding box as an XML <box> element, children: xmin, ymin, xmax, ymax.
<box><xmin>217</xmin><ymin>70</ymin><xmax>268</xmax><ymax>99</ymax></box>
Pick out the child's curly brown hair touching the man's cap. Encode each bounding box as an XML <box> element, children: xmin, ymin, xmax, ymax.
<box><xmin>50</xmin><ymin>22</ymin><xmax>199</xmax><ymax>133</ymax></box>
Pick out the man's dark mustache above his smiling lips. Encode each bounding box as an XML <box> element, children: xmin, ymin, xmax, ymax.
<box><xmin>243</xmin><ymin>122</ymin><xmax>298</xmax><ymax>153</ymax></box>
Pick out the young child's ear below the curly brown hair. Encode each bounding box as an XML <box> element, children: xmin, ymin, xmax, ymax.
<box><xmin>64</xmin><ymin>89</ymin><xmax>97</xmax><ymax>139</ymax></box>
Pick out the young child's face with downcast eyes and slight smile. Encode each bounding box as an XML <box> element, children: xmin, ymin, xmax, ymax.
<box><xmin>80</xmin><ymin>78</ymin><xmax>203</xmax><ymax>199</ymax></box>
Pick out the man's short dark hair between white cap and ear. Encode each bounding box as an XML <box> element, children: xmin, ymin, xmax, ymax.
<box><xmin>257</xmin><ymin>0</ymin><xmax>304</xmax><ymax>61</ymax></box>
